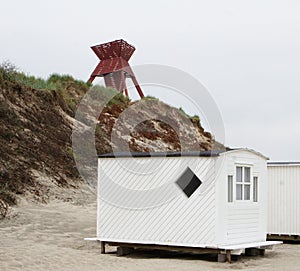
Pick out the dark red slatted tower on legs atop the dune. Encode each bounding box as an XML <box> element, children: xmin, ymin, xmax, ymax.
<box><xmin>89</xmin><ymin>39</ymin><xmax>144</xmax><ymax>98</ymax></box>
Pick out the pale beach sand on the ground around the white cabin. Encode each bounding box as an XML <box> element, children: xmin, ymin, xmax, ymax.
<box><xmin>0</xmin><ymin>187</ymin><xmax>300</xmax><ymax>271</ymax></box>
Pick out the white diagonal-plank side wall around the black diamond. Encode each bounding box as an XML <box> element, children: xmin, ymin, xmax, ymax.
<box><xmin>97</xmin><ymin>157</ymin><xmax>216</xmax><ymax>249</ymax></box>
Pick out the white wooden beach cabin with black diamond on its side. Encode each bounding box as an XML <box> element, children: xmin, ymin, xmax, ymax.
<box><xmin>88</xmin><ymin>149</ymin><xmax>279</xmax><ymax>261</ymax></box>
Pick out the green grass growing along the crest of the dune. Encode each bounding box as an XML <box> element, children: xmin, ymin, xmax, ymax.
<box><xmin>0</xmin><ymin>61</ymin><xmax>200</xmax><ymax>121</ymax></box>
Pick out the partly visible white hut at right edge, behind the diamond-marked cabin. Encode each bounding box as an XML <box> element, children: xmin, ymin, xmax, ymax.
<box><xmin>267</xmin><ymin>162</ymin><xmax>300</xmax><ymax>240</ymax></box>
